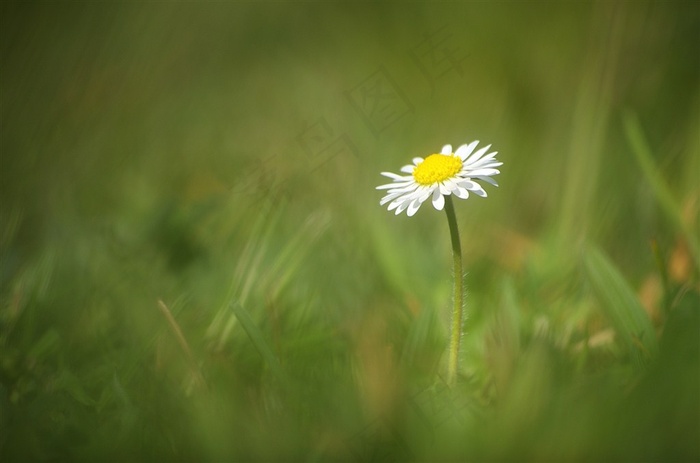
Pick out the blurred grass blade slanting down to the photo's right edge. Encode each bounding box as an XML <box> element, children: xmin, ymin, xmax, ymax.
<box><xmin>623</xmin><ymin>112</ymin><xmax>700</xmax><ymax>269</ymax></box>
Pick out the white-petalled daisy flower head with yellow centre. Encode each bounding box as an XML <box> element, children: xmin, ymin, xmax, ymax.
<box><xmin>377</xmin><ymin>141</ymin><xmax>503</xmax><ymax>217</ymax></box>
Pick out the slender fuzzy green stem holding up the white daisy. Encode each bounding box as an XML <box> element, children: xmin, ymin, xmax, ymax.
<box><xmin>445</xmin><ymin>196</ymin><xmax>464</xmax><ymax>386</ymax></box>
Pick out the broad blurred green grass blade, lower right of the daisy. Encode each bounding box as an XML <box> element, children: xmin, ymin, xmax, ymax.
<box><xmin>584</xmin><ymin>245</ymin><xmax>658</xmax><ymax>365</ymax></box>
